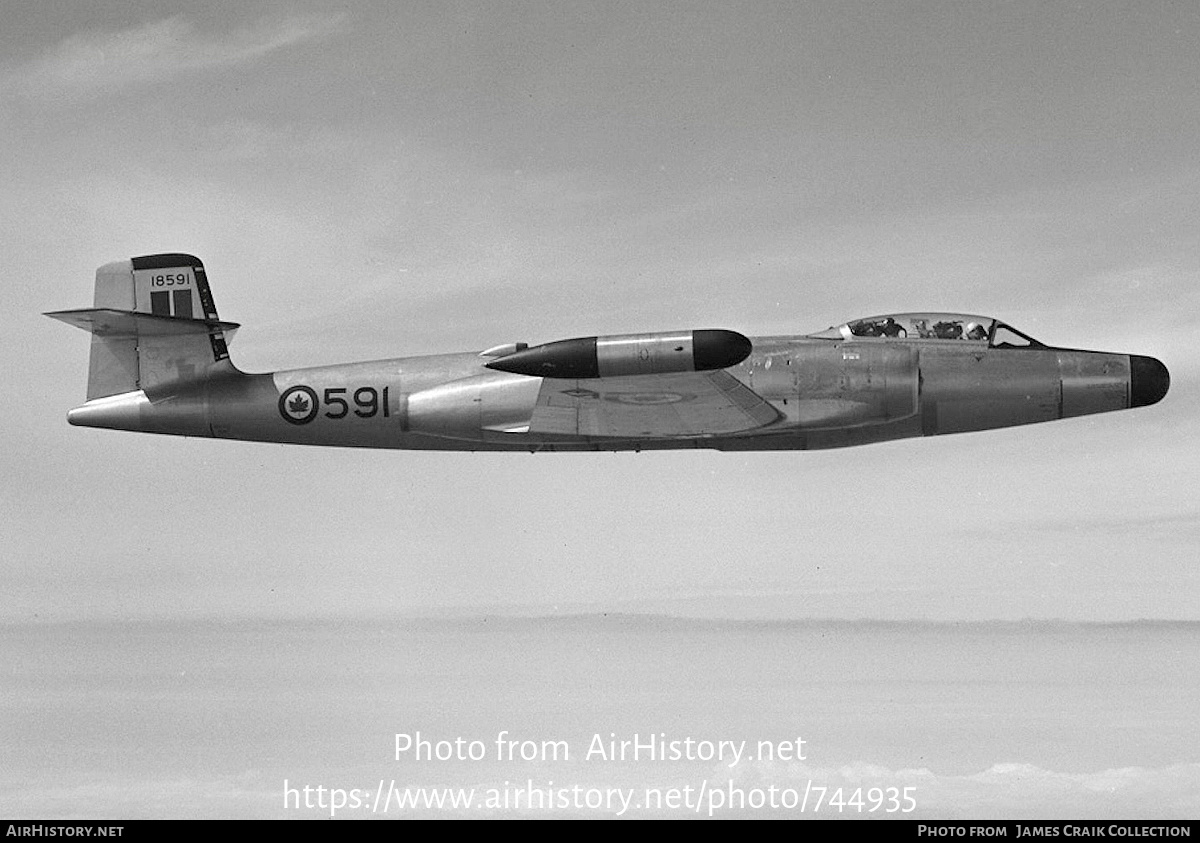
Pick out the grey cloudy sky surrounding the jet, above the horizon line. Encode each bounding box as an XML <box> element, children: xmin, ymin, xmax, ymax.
<box><xmin>0</xmin><ymin>0</ymin><xmax>1200</xmax><ymax>620</ymax></box>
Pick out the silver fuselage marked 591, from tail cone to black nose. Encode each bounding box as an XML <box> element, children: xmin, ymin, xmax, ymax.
<box><xmin>68</xmin><ymin>330</ymin><xmax>1169</xmax><ymax>452</ymax></box>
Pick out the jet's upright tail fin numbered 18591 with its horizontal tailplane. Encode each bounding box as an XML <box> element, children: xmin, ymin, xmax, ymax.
<box><xmin>47</xmin><ymin>255</ymin><xmax>238</xmax><ymax>401</ymax></box>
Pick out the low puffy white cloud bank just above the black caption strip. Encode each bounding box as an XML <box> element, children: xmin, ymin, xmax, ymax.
<box><xmin>0</xmin><ymin>761</ymin><xmax>1200</xmax><ymax>820</ymax></box>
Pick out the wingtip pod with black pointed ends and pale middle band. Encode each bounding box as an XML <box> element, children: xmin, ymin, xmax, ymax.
<box><xmin>486</xmin><ymin>329</ymin><xmax>754</xmax><ymax>378</ymax></box>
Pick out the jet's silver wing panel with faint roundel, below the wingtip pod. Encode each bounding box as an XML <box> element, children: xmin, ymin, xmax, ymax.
<box><xmin>529</xmin><ymin>371</ymin><xmax>780</xmax><ymax>440</ymax></box>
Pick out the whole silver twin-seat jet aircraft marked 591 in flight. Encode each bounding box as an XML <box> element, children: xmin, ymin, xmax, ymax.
<box><xmin>47</xmin><ymin>253</ymin><xmax>1170</xmax><ymax>452</ymax></box>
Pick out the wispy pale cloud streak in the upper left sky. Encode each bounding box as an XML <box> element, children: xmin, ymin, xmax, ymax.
<box><xmin>0</xmin><ymin>16</ymin><xmax>344</xmax><ymax>104</ymax></box>
